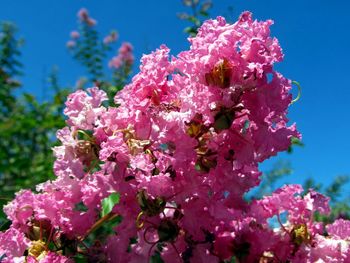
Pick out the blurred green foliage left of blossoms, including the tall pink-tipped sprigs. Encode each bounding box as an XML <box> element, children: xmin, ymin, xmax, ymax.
<box><xmin>0</xmin><ymin>13</ymin><xmax>132</xmax><ymax>225</ymax></box>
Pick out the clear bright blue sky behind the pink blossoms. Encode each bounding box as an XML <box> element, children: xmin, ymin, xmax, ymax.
<box><xmin>0</xmin><ymin>0</ymin><xmax>350</xmax><ymax>195</ymax></box>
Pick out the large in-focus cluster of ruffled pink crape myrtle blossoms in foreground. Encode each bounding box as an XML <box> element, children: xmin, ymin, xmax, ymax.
<box><xmin>0</xmin><ymin>12</ymin><xmax>350</xmax><ymax>263</ymax></box>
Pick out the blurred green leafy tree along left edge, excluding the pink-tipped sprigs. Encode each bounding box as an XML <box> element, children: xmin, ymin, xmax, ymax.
<box><xmin>0</xmin><ymin>22</ymin><xmax>68</xmax><ymax>223</ymax></box>
